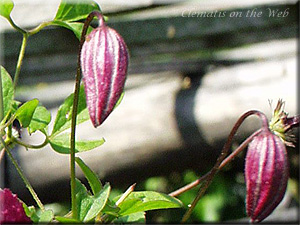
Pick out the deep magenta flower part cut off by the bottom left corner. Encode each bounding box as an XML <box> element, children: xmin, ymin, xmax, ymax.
<box><xmin>0</xmin><ymin>188</ymin><xmax>31</xmax><ymax>224</ymax></box>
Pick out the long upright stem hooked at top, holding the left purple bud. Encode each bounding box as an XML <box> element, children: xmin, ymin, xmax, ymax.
<box><xmin>70</xmin><ymin>11</ymin><xmax>102</xmax><ymax>218</ymax></box>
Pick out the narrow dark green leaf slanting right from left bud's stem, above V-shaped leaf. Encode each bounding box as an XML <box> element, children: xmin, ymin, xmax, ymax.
<box><xmin>75</xmin><ymin>157</ymin><xmax>102</xmax><ymax>195</ymax></box>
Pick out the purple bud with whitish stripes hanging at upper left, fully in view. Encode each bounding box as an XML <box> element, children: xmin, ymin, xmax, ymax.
<box><xmin>80</xmin><ymin>18</ymin><xmax>129</xmax><ymax>127</ymax></box>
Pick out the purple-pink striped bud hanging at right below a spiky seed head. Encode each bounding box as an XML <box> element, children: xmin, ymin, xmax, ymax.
<box><xmin>245</xmin><ymin>129</ymin><xmax>289</xmax><ymax>222</ymax></box>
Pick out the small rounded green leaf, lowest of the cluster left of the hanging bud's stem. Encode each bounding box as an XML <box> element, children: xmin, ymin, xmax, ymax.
<box><xmin>28</xmin><ymin>106</ymin><xmax>51</xmax><ymax>134</ymax></box>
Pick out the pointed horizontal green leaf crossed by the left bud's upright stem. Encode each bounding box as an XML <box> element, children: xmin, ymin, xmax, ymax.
<box><xmin>49</xmin><ymin>133</ymin><xmax>105</xmax><ymax>154</ymax></box>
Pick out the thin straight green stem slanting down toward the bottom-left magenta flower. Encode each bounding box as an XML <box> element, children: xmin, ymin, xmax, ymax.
<box><xmin>0</xmin><ymin>138</ymin><xmax>45</xmax><ymax>211</ymax></box>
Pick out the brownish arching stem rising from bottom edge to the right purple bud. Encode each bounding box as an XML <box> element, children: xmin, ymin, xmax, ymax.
<box><xmin>181</xmin><ymin>110</ymin><xmax>268</xmax><ymax>223</ymax></box>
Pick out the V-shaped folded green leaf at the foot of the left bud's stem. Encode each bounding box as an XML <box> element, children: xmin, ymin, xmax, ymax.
<box><xmin>76</xmin><ymin>179</ymin><xmax>111</xmax><ymax>222</ymax></box>
